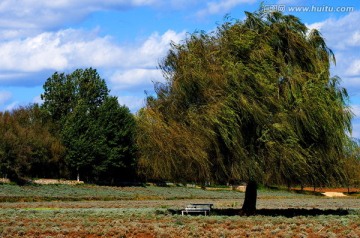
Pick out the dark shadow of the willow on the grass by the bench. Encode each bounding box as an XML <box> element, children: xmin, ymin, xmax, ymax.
<box><xmin>168</xmin><ymin>208</ymin><xmax>351</xmax><ymax>218</ymax></box>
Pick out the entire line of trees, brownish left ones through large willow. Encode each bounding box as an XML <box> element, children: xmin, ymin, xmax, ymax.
<box><xmin>0</xmin><ymin>11</ymin><xmax>360</xmax><ymax>213</ymax></box>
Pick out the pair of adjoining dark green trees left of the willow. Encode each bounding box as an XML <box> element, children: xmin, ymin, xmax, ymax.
<box><xmin>41</xmin><ymin>68</ymin><xmax>135</xmax><ymax>182</ymax></box>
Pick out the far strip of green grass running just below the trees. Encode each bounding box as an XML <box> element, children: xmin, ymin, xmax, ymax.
<box><xmin>0</xmin><ymin>184</ymin><xmax>316</xmax><ymax>202</ymax></box>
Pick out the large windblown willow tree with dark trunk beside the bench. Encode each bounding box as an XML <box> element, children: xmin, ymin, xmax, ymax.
<box><xmin>137</xmin><ymin>12</ymin><xmax>352</xmax><ymax>213</ymax></box>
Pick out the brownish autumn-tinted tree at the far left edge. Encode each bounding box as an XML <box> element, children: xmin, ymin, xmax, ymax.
<box><xmin>0</xmin><ymin>104</ymin><xmax>64</xmax><ymax>184</ymax></box>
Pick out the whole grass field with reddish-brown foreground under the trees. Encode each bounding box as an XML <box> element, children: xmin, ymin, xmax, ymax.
<box><xmin>0</xmin><ymin>185</ymin><xmax>360</xmax><ymax>237</ymax></box>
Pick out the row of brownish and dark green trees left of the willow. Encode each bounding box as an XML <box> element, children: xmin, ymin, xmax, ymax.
<box><xmin>0</xmin><ymin>68</ymin><xmax>135</xmax><ymax>184</ymax></box>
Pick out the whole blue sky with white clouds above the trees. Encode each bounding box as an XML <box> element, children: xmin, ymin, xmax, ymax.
<box><xmin>0</xmin><ymin>0</ymin><xmax>360</xmax><ymax>138</ymax></box>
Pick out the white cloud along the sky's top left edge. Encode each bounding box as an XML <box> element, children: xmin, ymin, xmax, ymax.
<box><xmin>0</xmin><ymin>0</ymin><xmax>158</xmax><ymax>35</ymax></box>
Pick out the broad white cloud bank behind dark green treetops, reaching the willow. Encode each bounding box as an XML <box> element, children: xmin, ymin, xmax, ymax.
<box><xmin>0</xmin><ymin>26</ymin><xmax>186</xmax><ymax>112</ymax></box>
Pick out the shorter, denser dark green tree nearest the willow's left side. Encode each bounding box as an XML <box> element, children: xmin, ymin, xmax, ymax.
<box><xmin>94</xmin><ymin>97</ymin><xmax>136</xmax><ymax>184</ymax></box>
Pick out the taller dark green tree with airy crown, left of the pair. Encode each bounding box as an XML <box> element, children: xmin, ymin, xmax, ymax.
<box><xmin>41</xmin><ymin>68</ymin><xmax>109</xmax><ymax>179</ymax></box>
